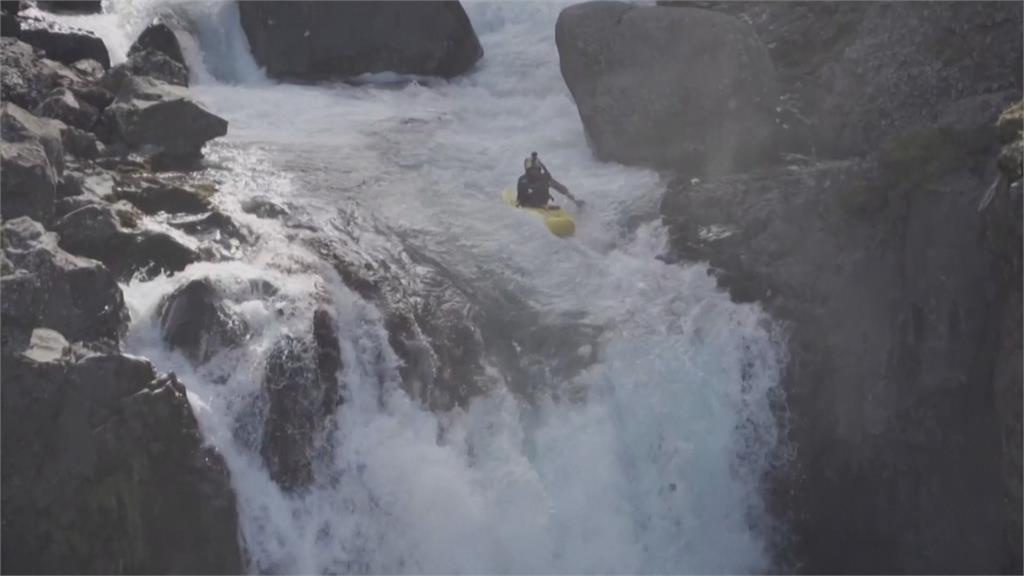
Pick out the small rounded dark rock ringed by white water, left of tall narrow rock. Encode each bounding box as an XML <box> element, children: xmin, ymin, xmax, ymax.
<box><xmin>160</xmin><ymin>279</ymin><xmax>248</xmax><ymax>364</ymax></box>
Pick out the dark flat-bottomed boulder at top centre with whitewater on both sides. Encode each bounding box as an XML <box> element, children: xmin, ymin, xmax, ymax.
<box><xmin>239</xmin><ymin>1</ymin><xmax>483</xmax><ymax>80</ymax></box>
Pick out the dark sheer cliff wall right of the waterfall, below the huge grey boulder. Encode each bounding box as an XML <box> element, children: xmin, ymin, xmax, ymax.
<box><xmin>662</xmin><ymin>119</ymin><xmax>1020</xmax><ymax>572</ymax></box>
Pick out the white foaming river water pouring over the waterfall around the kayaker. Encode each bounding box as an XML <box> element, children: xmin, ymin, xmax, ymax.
<box><xmin>68</xmin><ymin>2</ymin><xmax>781</xmax><ymax>573</ymax></box>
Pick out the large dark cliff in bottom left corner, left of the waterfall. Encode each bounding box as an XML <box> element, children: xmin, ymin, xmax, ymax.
<box><xmin>2</xmin><ymin>330</ymin><xmax>243</xmax><ymax>573</ymax></box>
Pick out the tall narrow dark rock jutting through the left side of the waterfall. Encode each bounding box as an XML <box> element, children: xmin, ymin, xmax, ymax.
<box><xmin>260</xmin><ymin>310</ymin><xmax>344</xmax><ymax>490</ymax></box>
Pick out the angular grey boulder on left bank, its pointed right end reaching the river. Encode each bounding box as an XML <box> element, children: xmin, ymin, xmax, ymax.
<box><xmin>103</xmin><ymin>77</ymin><xmax>227</xmax><ymax>162</ymax></box>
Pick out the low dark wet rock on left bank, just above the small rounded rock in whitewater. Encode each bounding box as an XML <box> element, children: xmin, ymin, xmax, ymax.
<box><xmin>53</xmin><ymin>203</ymin><xmax>200</xmax><ymax>278</ymax></box>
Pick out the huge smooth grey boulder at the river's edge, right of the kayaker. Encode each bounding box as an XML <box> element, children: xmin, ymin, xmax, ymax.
<box><xmin>555</xmin><ymin>2</ymin><xmax>777</xmax><ymax>174</ymax></box>
